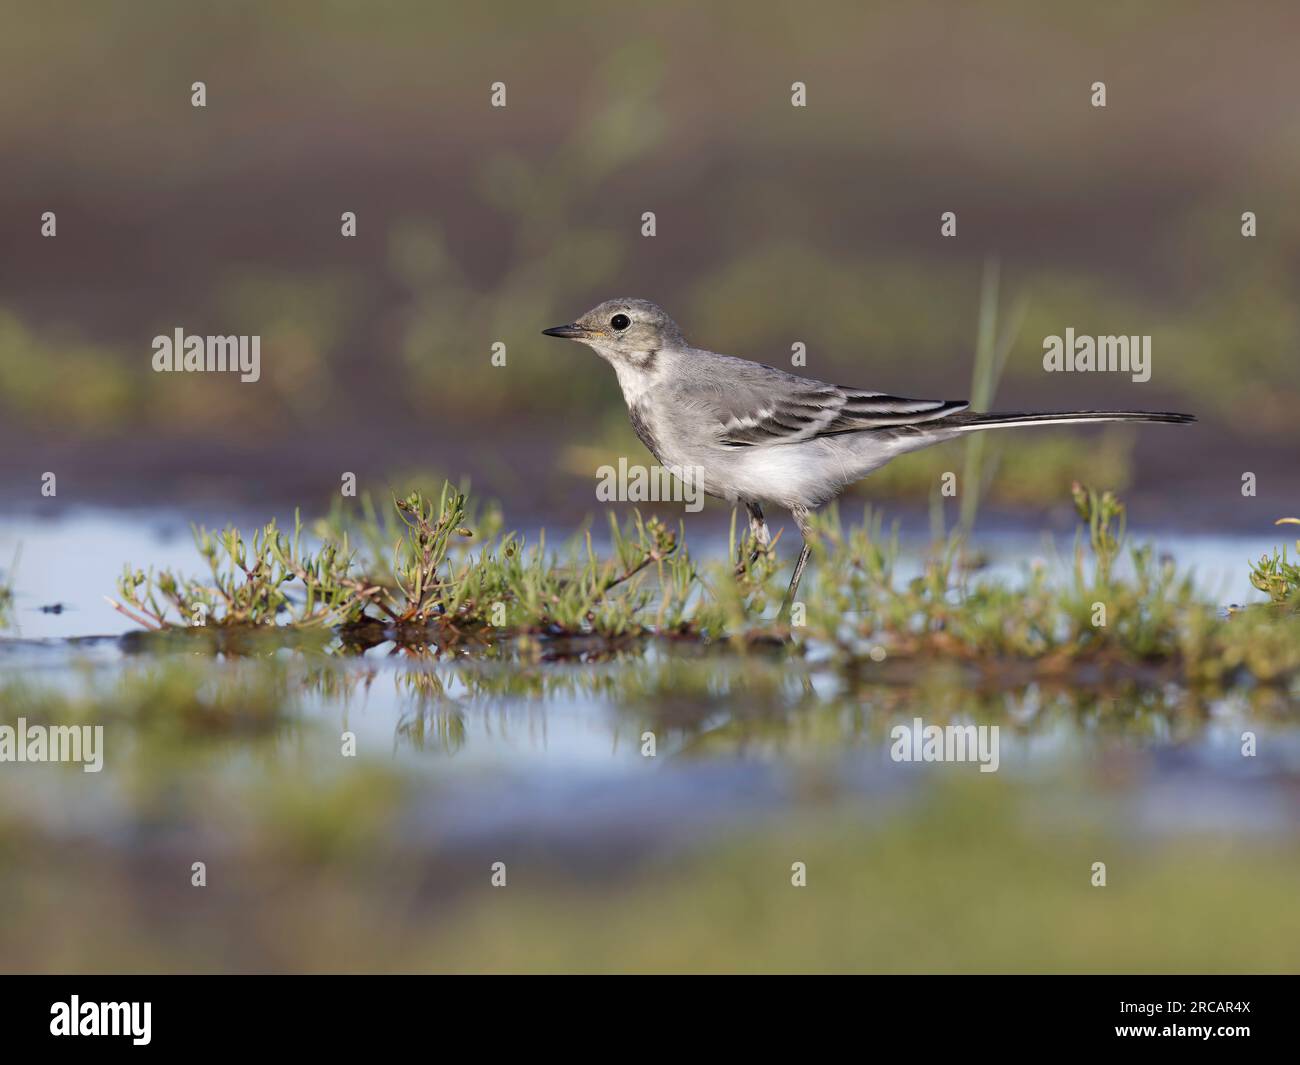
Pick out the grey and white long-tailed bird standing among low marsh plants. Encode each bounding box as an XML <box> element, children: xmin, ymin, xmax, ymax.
<box><xmin>542</xmin><ymin>298</ymin><xmax>1196</xmax><ymax>611</ymax></box>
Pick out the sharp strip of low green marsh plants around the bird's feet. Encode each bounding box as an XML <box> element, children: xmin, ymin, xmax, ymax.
<box><xmin>114</xmin><ymin>484</ymin><xmax>1300</xmax><ymax>684</ymax></box>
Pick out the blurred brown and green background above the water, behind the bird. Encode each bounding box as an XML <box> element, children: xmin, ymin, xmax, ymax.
<box><xmin>0</xmin><ymin>0</ymin><xmax>1300</xmax><ymax>512</ymax></box>
